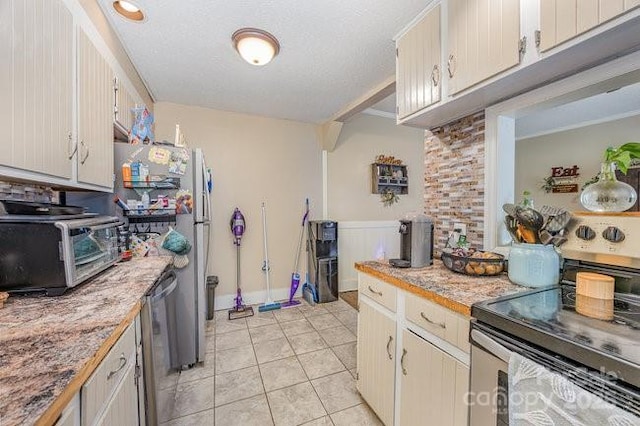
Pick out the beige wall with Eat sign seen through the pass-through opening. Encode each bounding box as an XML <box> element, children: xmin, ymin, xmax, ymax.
<box><xmin>515</xmin><ymin>116</ymin><xmax>640</xmax><ymax>210</ymax></box>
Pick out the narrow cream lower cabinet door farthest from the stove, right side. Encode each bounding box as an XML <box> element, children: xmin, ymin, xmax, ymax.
<box><xmin>357</xmin><ymin>297</ymin><xmax>396</xmax><ymax>425</ymax></box>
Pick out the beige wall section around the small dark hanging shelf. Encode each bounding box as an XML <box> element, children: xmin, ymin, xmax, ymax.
<box><xmin>327</xmin><ymin>114</ymin><xmax>424</xmax><ymax>222</ymax></box>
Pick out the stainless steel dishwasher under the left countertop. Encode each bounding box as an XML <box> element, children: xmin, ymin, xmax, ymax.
<box><xmin>140</xmin><ymin>270</ymin><xmax>180</xmax><ymax>426</ymax></box>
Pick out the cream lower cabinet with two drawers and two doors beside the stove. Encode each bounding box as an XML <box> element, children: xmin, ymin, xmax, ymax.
<box><xmin>357</xmin><ymin>272</ymin><xmax>469</xmax><ymax>426</ymax></box>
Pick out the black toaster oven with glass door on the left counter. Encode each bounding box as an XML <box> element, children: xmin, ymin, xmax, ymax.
<box><xmin>0</xmin><ymin>214</ymin><xmax>121</xmax><ymax>296</ymax></box>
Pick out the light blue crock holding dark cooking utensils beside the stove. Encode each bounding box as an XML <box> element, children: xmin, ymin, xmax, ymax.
<box><xmin>508</xmin><ymin>243</ymin><xmax>560</xmax><ymax>287</ymax></box>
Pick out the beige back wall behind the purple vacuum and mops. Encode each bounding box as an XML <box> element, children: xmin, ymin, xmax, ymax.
<box><xmin>155</xmin><ymin>102</ymin><xmax>322</xmax><ymax>309</ymax></box>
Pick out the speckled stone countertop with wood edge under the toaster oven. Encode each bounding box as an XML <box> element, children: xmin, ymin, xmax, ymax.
<box><xmin>0</xmin><ymin>257</ymin><xmax>171</xmax><ymax>426</ymax></box>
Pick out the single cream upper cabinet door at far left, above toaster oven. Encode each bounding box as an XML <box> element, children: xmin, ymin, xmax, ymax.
<box><xmin>0</xmin><ymin>0</ymin><xmax>74</xmax><ymax>179</ymax></box>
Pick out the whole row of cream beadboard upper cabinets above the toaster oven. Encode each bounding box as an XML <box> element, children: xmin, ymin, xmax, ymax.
<box><xmin>0</xmin><ymin>0</ymin><xmax>145</xmax><ymax>191</ymax></box>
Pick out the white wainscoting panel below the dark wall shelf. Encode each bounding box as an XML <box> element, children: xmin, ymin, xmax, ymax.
<box><xmin>338</xmin><ymin>220</ymin><xmax>400</xmax><ymax>291</ymax></box>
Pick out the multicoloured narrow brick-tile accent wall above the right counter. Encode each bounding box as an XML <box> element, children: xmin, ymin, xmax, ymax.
<box><xmin>424</xmin><ymin>111</ymin><xmax>485</xmax><ymax>253</ymax></box>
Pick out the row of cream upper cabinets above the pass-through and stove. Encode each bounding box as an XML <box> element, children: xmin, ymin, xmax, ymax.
<box><xmin>396</xmin><ymin>0</ymin><xmax>640</xmax><ymax>129</ymax></box>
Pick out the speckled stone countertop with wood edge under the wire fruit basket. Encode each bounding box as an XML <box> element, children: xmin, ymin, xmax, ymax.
<box><xmin>355</xmin><ymin>260</ymin><xmax>530</xmax><ymax>316</ymax></box>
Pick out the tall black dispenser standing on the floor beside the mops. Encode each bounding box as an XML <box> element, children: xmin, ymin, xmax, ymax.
<box><xmin>307</xmin><ymin>220</ymin><xmax>338</xmax><ymax>303</ymax></box>
